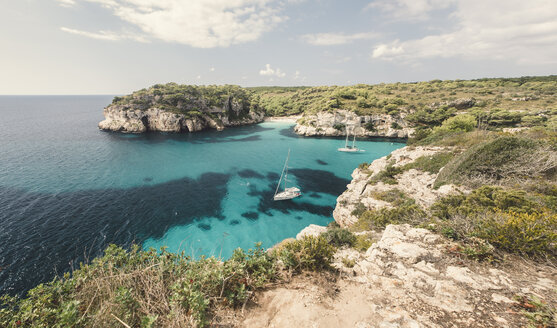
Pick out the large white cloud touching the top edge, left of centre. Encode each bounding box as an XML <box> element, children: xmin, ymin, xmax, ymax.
<box><xmin>62</xmin><ymin>0</ymin><xmax>286</xmax><ymax>48</ymax></box>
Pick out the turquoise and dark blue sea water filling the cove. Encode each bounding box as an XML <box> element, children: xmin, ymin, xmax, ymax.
<box><xmin>0</xmin><ymin>96</ymin><xmax>403</xmax><ymax>294</ymax></box>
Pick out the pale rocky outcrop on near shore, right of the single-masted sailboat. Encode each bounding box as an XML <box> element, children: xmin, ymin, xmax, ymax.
<box><xmin>333</xmin><ymin>147</ymin><xmax>466</xmax><ymax>227</ymax></box>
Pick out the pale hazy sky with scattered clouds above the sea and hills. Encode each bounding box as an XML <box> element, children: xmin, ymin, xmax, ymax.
<box><xmin>0</xmin><ymin>0</ymin><xmax>557</xmax><ymax>95</ymax></box>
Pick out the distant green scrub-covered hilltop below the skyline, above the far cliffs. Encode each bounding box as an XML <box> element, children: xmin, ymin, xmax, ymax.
<box><xmin>112</xmin><ymin>75</ymin><xmax>557</xmax><ymax>133</ymax></box>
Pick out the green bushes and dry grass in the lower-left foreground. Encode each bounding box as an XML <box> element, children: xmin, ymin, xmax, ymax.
<box><xmin>0</xmin><ymin>237</ymin><xmax>335</xmax><ymax>327</ymax></box>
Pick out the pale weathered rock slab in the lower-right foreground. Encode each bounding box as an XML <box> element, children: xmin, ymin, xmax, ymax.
<box><xmin>326</xmin><ymin>225</ymin><xmax>556</xmax><ymax>327</ymax></box>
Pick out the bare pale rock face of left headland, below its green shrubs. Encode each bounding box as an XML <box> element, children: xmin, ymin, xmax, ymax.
<box><xmin>99</xmin><ymin>105</ymin><xmax>264</xmax><ymax>133</ymax></box>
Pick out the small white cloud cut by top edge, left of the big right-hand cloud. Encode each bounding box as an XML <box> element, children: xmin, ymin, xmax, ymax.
<box><xmin>366</xmin><ymin>0</ymin><xmax>457</xmax><ymax>20</ymax></box>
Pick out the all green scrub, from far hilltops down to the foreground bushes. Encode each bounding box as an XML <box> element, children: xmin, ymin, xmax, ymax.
<box><xmin>4</xmin><ymin>76</ymin><xmax>557</xmax><ymax>327</ymax></box>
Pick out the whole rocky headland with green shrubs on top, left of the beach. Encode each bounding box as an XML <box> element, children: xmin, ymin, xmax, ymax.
<box><xmin>99</xmin><ymin>83</ymin><xmax>264</xmax><ymax>133</ymax></box>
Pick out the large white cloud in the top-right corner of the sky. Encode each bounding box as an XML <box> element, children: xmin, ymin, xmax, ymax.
<box><xmin>372</xmin><ymin>0</ymin><xmax>557</xmax><ymax>64</ymax></box>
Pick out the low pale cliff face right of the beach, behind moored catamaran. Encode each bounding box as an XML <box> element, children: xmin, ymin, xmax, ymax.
<box><xmin>294</xmin><ymin>110</ymin><xmax>414</xmax><ymax>138</ymax></box>
